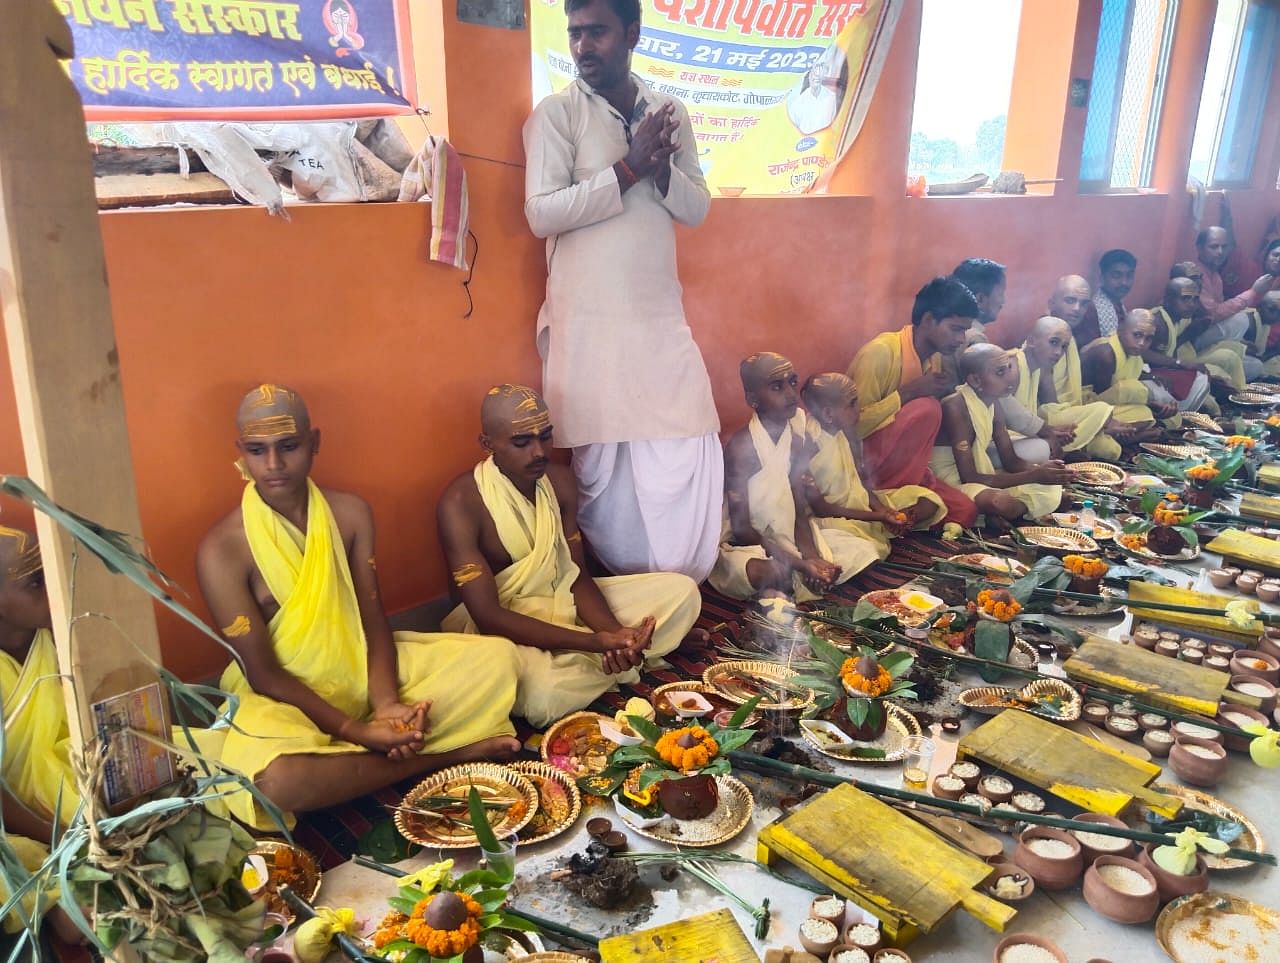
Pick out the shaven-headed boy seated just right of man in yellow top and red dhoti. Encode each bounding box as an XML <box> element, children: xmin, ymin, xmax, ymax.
<box><xmin>929</xmin><ymin>344</ymin><xmax>1071</xmax><ymax>521</ymax></box>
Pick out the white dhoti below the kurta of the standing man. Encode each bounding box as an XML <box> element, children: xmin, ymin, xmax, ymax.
<box><xmin>573</xmin><ymin>434</ymin><xmax>724</xmax><ymax>581</ymax></box>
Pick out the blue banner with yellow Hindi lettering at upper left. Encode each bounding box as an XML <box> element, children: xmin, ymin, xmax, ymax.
<box><xmin>58</xmin><ymin>0</ymin><xmax>415</xmax><ymax>120</ymax></box>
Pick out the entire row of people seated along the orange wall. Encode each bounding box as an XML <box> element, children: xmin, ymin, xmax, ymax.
<box><xmin>10</xmin><ymin>228</ymin><xmax>1280</xmax><ymax>916</ymax></box>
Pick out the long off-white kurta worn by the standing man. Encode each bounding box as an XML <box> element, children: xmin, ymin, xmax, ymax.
<box><xmin>525</xmin><ymin>76</ymin><xmax>719</xmax><ymax>447</ymax></box>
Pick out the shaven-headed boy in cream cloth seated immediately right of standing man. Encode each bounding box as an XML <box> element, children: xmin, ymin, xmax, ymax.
<box><xmin>710</xmin><ymin>351</ymin><xmax>879</xmax><ymax>601</ymax></box>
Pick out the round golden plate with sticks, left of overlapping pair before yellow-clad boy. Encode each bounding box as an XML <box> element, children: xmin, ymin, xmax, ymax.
<box><xmin>396</xmin><ymin>762</ymin><xmax>538</xmax><ymax>849</ymax></box>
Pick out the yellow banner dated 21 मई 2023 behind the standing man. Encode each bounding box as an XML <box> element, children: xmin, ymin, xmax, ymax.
<box><xmin>530</xmin><ymin>0</ymin><xmax>900</xmax><ymax>196</ymax></box>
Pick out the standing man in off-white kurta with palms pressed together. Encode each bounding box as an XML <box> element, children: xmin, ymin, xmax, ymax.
<box><xmin>525</xmin><ymin>0</ymin><xmax>724</xmax><ymax>581</ymax></box>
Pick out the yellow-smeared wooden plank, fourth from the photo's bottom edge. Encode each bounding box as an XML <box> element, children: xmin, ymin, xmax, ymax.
<box><xmin>1062</xmin><ymin>639</ymin><xmax>1231</xmax><ymax>718</ymax></box>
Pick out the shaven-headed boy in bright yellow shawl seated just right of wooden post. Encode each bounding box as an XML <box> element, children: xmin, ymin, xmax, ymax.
<box><xmin>196</xmin><ymin>384</ymin><xmax>520</xmax><ymax>829</ymax></box>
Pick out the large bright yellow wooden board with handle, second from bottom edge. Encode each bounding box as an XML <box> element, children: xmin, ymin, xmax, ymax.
<box><xmin>756</xmin><ymin>783</ymin><xmax>1013</xmax><ymax>946</ymax></box>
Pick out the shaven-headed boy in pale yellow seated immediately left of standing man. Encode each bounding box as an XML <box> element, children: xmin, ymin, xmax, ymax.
<box><xmin>435</xmin><ymin>384</ymin><xmax>701</xmax><ymax>727</ymax></box>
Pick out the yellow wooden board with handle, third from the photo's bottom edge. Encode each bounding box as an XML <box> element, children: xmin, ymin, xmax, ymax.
<box><xmin>960</xmin><ymin>712</ymin><xmax>1181</xmax><ymax>816</ymax></box>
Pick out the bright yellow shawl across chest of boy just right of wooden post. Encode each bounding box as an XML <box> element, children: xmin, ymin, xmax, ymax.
<box><xmin>221</xmin><ymin>480</ymin><xmax>369</xmax><ymax>718</ymax></box>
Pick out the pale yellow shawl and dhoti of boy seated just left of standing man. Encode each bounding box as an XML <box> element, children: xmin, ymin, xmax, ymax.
<box><xmin>444</xmin><ymin>457</ymin><xmax>701</xmax><ymax>727</ymax></box>
